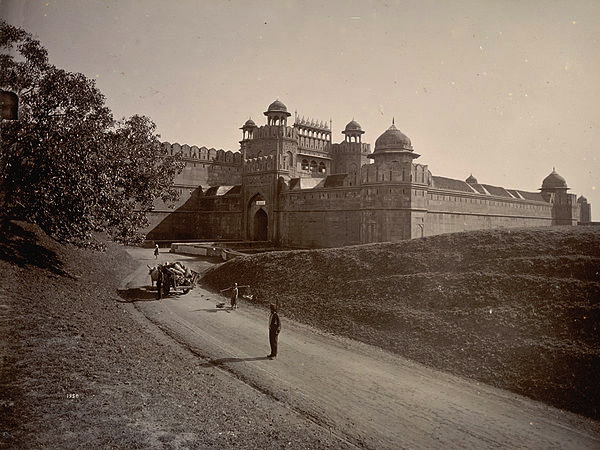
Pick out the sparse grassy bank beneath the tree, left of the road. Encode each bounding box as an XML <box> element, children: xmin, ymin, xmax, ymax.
<box><xmin>0</xmin><ymin>221</ymin><xmax>344</xmax><ymax>449</ymax></box>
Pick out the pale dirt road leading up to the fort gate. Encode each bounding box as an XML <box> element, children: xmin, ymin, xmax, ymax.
<box><xmin>126</xmin><ymin>249</ymin><xmax>600</xmax><ymax>449</ymax></box>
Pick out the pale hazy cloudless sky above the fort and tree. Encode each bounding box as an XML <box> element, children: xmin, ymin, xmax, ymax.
<box><xmin>0</xmin><ymin>0</ymin><xmax>600</xmax><ymax>220</ymax></box>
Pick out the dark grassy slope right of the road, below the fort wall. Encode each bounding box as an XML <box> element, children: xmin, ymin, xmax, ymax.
<box><xmin>204</xmin><ymin>227</ymin><xmax>600</xmax><ymax>419</ymax></box>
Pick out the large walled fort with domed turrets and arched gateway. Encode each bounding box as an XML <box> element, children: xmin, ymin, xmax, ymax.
<box><xmin>147</xmin><ymin>100</ymin><xmax>591</xmax><ymax>248</ymax></box>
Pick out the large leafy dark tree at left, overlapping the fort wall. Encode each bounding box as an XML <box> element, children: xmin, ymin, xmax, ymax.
<box><xmin>0</xmin><ymin>21</ymin><xmax>182</xmax><ymax>245</ymax></box>
